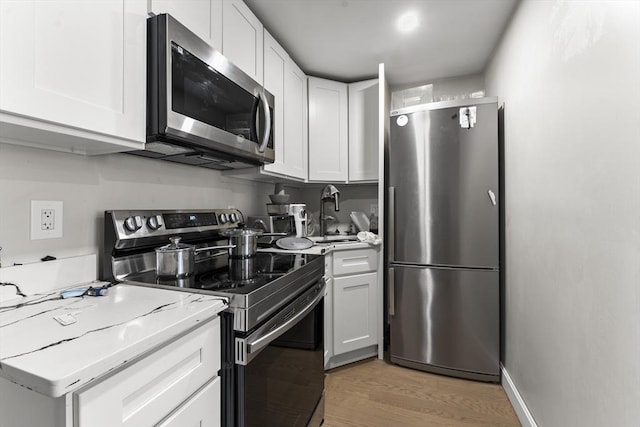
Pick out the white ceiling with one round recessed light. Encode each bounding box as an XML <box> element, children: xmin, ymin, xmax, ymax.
<box><xmin>244</xmin><ymin>0</ymin><xmax>519</xmax><ymax>87</ymax></box>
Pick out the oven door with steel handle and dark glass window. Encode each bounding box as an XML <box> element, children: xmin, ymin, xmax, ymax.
<box><xmin>235</xmin><ymin>281</ymin><xmax>325</xmax><ymax>427</ymax></box>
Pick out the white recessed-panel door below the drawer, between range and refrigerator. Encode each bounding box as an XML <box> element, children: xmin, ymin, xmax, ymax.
<box><xmin>333</xmin><ymin>273</ymin><xmax>378</xmax><ymax>355</ymax></box>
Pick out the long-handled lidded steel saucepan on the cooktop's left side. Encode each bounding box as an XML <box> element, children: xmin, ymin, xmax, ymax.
<box><xmin>156</xmin><ymin>237</ymin><xmax>235</xmax><ymax>278</ymax></box>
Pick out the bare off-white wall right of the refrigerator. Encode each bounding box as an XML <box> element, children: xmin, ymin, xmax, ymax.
<box><xmin>485</xmin><ymin>0</ymin><xmax>640</xmax><ymax>427</ymax></box>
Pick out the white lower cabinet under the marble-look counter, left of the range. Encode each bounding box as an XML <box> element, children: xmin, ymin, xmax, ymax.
<box><xmin>0</xmin><ymin>317</ymin><xmax>221</xmax><ymax>427</ymax></box>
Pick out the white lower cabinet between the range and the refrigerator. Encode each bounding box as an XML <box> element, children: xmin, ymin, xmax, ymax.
<box><xmin>325</xmin><ymin>248</ymin><xmax>381</xmax><ymax>369</ymax></box>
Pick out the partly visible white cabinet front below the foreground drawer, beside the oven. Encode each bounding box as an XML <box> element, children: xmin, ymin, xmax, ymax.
<box><xmin>158</xmin><ymin>377</ymin><xmax>221</xmax><ymax>427</ymax></box>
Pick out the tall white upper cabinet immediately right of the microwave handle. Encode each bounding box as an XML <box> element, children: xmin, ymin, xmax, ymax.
<box><xmin>264</xmin><ymin>31</ymin><xmax>307</xmax><ymax>180</ymax></box>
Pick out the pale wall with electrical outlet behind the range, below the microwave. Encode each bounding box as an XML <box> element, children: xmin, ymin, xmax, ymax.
<box><xmin>0</xmin><ymin>144</ymin><xmax>273</xmax><ymax>266</ymax></box>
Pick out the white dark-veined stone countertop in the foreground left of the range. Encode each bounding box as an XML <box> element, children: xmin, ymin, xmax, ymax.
<box><xmin>0</xmin><ymin>282</ymin><xmax>227</xmax><ymax>397</ymax></box>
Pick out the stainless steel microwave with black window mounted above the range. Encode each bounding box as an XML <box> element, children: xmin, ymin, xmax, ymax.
<box><xmin>132</xmin><ymin>14</ymin><xmax>275</xmax><ymax>170</ymax></box>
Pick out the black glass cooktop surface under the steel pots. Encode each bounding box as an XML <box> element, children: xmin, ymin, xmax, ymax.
<box><xmin>127</xmin><ymin>252</ymin><xmax>320</xmax><ymax>294</ymax></box>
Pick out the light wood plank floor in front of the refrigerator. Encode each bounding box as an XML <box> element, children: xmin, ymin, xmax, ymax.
<box><xmin>324</xmin><ymin>359</ymin><xmax>520</xmax><ymax>427</ymax></box>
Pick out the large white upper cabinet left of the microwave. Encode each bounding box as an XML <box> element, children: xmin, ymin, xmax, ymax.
<box><xmin>0</xmin><ymin>0</ymin><xmax>147</xmax><ymax>154</ymax></box>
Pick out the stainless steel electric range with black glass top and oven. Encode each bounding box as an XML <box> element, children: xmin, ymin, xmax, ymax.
<box><xmin>103</xmin><ymin>209</ymin><xmax>325</xmax><ymax>426</ymax></box>
